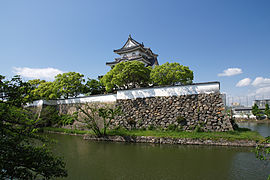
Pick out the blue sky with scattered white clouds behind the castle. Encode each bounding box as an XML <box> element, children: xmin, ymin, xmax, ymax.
<box><xmin>0</xmin><ymin>0</ymin><xmax>270</xmax><ymax>103</ymax></box>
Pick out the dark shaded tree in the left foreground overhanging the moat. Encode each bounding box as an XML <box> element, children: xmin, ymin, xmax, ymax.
<box><xmin>0</xmin><ymin>76</ymin><xmax>67</xmax><ymax>179</ymax></box>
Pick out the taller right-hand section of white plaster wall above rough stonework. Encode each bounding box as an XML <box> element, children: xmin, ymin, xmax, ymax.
<box><xmin>117</xmin><ymin>82</ymin><xmax>219</xmax><ymax>99</ymax></box>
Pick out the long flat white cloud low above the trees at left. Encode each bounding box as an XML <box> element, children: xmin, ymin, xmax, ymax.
<box><xmin>13</xmin><ymin>67</ymin><xmax>63</xmax><ymax>80</ymax></box>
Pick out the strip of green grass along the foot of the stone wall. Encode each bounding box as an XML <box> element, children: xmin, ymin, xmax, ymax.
<box><xmin>44</xmin><ymin>127</ymin><xmax>264</xmax><ymax>141</ymax></box>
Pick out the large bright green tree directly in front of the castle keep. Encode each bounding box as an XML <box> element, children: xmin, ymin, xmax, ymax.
<box><xmin>101</xmin><ymin>61</ymin><xmax>151</xmax><ymax>92</ymax></box>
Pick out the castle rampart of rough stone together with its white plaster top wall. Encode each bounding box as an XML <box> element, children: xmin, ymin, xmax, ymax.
<box><xmin>25</xmin><ymin>82</ymin><xmax>233</xmax><ymax>131</ymax></box>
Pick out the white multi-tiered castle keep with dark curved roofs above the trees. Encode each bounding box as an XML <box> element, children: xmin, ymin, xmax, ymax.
<box><xmin>106</xmin><ymin>35</ymin><xmax>158</xmax><ymax>67</ymax></box>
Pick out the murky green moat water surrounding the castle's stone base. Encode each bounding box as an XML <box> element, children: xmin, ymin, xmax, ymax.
<box><xmin>49</xmin><ymin>123</ymin><xmax>270</xmax><ymax>180</ymax></box>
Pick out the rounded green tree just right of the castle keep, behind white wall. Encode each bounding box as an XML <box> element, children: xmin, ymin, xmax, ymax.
<box><xmin>150</xmin><ymin>62</ymin><xmax>193</xmax><ymax>85</ymax></box>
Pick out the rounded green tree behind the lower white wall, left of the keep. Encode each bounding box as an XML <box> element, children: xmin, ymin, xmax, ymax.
<box><xmin>54</xmin><ymin>72</ymin><xmax>85</xmax><ymax>99</ymax></box>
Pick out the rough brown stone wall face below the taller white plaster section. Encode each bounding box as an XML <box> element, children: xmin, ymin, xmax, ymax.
<box><xmin>112</xmin><ymin>93</ymin><xmax>233</xmax><ymax>131</ymax></box>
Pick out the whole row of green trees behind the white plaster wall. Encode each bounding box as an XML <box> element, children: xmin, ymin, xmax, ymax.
<box><xmin>25</xmin><ymin>61</ymin><xmax>193</xmax><ymax>100</ymax></box>
